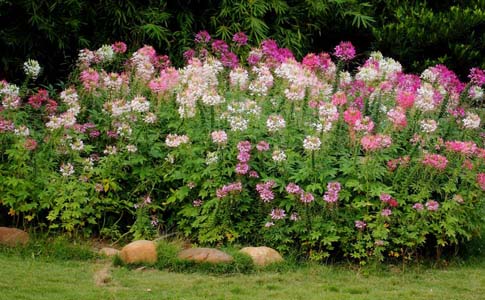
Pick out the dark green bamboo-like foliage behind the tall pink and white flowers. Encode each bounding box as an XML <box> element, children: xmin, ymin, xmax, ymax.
<box><xmin>0</xmin><ymin>0</ymin><xmax>485</xmax><ymax>82</ymax></box>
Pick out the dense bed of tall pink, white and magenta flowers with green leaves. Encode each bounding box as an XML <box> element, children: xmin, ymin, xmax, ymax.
<box><xmin>0</xmin><ymin>32</ymin><xmax>485</xmax><ymax>260</ymax></box>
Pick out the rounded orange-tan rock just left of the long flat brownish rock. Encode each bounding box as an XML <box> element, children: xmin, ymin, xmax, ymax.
<box><xmin>120</xmin><ymin>240</ymin><xmax>157</xmax><ymax>264</ymax></box>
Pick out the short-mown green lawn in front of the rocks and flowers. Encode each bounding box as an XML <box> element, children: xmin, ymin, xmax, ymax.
<box><xmin>0</xmin><ymin>253</ymin><xmax>485</xmax><ymax>300</ymax></box>
